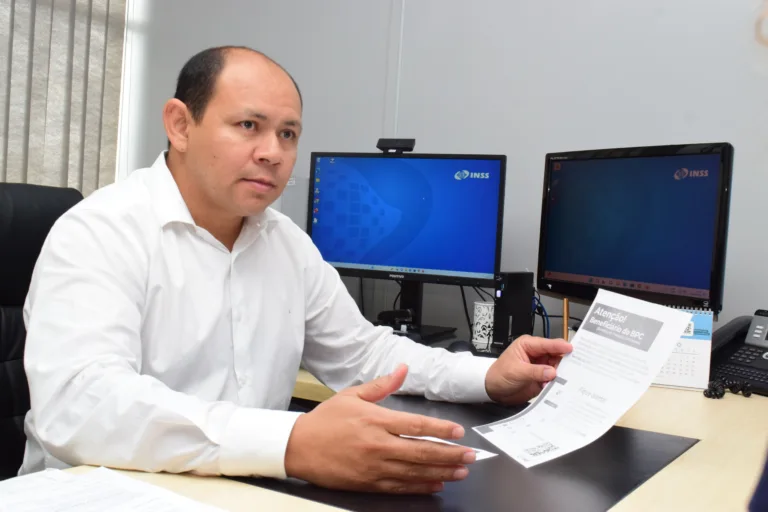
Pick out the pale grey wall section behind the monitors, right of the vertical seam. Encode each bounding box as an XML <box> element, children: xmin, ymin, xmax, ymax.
<box><xmin>398</xmin><ymin>0</ymin><xmax>768</xmax><ymax>332</ymax></box>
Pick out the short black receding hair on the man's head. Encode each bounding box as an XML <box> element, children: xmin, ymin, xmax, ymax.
<box><xmin>173</xmin><ymin>46</ymin><xmax>304</xmax><ymax>123</ymax></box>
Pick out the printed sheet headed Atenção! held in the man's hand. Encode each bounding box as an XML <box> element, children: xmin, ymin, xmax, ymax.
<box><xmin>474</xmin><ymin>290</ymin><xmax>691</xmax><ymax>468</ymax></box>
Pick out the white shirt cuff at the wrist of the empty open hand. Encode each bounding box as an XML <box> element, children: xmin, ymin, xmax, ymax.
<box><xmin>219</xmin><ymin>407</ymin><xmax>302</xmax><ymax>479</ymax></box>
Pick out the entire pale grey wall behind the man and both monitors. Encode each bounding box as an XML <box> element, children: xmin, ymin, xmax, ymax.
<box><xmin>121</xmin><ymin>0</ymin><xmax>768</xmax><ymax>340</ymax></box>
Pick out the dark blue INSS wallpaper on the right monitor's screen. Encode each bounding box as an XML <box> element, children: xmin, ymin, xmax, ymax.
<box><xmin>545</xmin><ymin>154</ymin><xmax>720</xmax><ymax>289</ymax></box>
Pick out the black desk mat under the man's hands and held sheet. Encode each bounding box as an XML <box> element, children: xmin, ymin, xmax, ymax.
<box><xmin>237</xmin><ymin>397</ymin><xmax>698</xmax><ymax>512</ymax></box>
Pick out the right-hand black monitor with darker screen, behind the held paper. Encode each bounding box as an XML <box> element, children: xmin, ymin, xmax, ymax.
<box><xmin>537</xmin><ymin>143</ymin><xmax>733</xmax><ymax>313</ymax></box>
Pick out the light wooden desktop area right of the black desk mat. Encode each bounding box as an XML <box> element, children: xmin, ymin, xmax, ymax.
<box><xmin>611</xmin><ymin>387</ymin><xmax>768</xmax><ymax>512</ymax></box>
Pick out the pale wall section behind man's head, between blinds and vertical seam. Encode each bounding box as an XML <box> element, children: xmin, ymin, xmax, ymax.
<box><xmin>120</xmin><ymin>0</ymin><xmax>400</xmax><ymax>176</ymax></box>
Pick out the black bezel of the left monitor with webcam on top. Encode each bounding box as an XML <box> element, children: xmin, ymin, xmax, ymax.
<box><xmin>306</xmin><ymin>151</ymin><xmax>507</xmax><ymax>287</ymax></box>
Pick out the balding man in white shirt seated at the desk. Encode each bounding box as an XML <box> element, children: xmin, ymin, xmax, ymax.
<box><xmin>21</xmin><ymin>47</ymin><xmax>570</xmax><ymax>493</ymax></box>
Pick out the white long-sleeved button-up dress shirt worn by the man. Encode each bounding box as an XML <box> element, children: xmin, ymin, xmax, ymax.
<box><xmin>20</xmin><ymin>154</ymin><xmax>492</xmax><ymax>478</ymax></box>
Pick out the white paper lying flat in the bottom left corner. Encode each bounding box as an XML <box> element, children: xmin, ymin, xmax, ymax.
<box><xmin>0</xmin><ymin>468</ymin><xmax>223</xmax><ymax>512</ymax></box>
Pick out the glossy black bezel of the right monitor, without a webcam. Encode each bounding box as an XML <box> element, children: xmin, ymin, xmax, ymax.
<box><xmin>536</xmin><ymin>142</ymin><xmax>734</xmax><ymax>314</ymax></box>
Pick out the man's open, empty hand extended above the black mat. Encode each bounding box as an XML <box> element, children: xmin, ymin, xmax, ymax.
<box><xmin>285</xmin><ymin>365</ymin><xmax>475</xmax><ymax>494</ymax></box>
